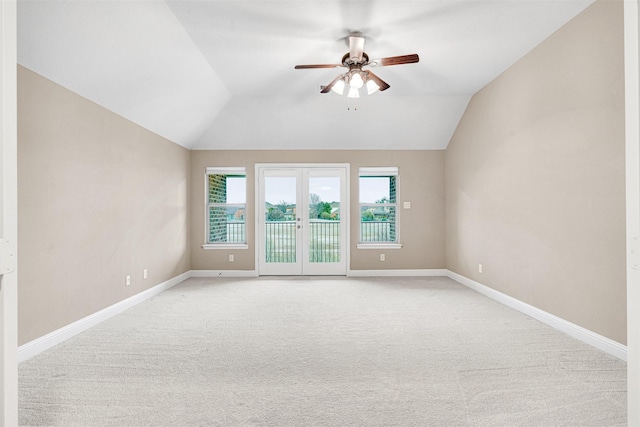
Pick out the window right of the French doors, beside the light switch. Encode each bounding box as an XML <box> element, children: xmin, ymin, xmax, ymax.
<box><xmin>359</xmin><ymin>167</ymin><xmax>399</xmax><ymax>247</ymax></box>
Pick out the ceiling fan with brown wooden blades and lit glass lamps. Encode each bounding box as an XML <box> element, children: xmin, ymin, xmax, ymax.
<box><xmin>295</xmin><ymin>33</ymin><xmax>420</xmax><ymax>98</ymax></box>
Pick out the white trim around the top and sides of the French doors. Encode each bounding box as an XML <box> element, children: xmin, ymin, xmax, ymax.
<box><xmin>254</xmin><ymin>163</ymin><xmax>351</xmax><ymax>276</ymax></box>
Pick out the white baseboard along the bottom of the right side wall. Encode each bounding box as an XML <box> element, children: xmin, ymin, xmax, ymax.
<box><xmin>446</xmin><ymin>270</ymin><xmax>627</xmax><ymax>362</ymax></box>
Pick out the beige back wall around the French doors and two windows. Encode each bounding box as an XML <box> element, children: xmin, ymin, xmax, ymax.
<box><xmin>191</xmin><ymin>150</ymin><xmax>445</xmax><ymax>270</ymax></box>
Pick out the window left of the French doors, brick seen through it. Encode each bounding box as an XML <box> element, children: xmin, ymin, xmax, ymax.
<box><xmin>203</xmin><ymin>168</ymin><xmax>247</xmax><ymax>249</ymax></box>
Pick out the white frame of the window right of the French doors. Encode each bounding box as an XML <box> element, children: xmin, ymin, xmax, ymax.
<box><xmin>356</xmin><ymin>166</ymin><xmax>402</xmax><ymax>249</ymax></box>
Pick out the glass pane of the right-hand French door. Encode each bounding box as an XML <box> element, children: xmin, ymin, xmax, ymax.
<box><xmin>309</xmin><ymin>177</ymin><xmax>340</xmax><ymax>263</ymax></box>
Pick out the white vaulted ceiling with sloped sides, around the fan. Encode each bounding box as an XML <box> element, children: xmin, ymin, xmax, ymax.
<box><xmin>18</xmin><ymin>0</ymin><xmax>593</xmax><ymax>149</ymax></box>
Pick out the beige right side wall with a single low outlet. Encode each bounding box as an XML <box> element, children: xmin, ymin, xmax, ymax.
<box><xmin>445</xmin><ymin>1</ymin><xmax>626</xmax><ymax>343</ymax></box>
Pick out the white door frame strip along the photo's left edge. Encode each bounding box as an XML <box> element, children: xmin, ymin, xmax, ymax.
<box><xmin>0</xmin><ymin>0</ymin><xmax>18</xmax><ymax>426</ymax></box>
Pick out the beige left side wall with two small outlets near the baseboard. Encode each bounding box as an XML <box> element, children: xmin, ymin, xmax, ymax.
<box><xmin>18</xmin><ymin>67</ymin><xmax>189</xmax><ymax>344</ymax></box>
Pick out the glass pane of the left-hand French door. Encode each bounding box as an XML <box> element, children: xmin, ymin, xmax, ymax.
<box><xmin>264</xmin><ymin>176</ymin><xmax>296</xmax><ymax>263</ymax></box>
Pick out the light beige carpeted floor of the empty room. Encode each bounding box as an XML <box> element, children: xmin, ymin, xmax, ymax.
<box><xmin>19</xmin><ymin>277</ymin><xmax>627</xmax><ymax>427</ymax></box>
